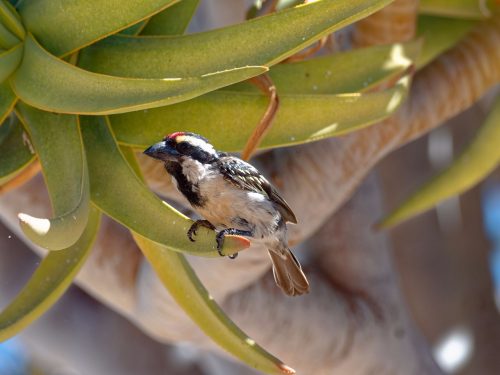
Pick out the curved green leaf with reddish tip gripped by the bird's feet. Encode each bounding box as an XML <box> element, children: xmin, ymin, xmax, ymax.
<box><xmin>81</xmin><ymin>117</ymin><xmax>249</xmax><ymax>257</ymax></box>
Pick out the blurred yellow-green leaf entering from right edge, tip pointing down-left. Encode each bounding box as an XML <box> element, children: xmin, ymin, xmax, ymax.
<box><xmin>380</xmin><ymin>97</ymin><xmax>500</xmax><ymax>227</ymax></box>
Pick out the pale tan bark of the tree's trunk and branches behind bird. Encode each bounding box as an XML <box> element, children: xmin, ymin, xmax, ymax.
<box><xmin>0</xmin><ymin>1</ymin><xmax>500</xmax><ymax>374</ymax></box>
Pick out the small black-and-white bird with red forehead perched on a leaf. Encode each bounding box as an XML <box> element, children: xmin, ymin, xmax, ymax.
<box><xmin>144</xmin><ymin>132</ymin><xmax>309</xmax><ymax>296</ymax></box>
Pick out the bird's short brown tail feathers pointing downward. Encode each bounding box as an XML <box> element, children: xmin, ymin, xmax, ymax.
<box><xmin>269</xmin><ymin>249</ymin><xmax>309</xmax><ymax>296</ymax></box>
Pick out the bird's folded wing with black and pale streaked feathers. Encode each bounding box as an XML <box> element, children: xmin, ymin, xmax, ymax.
<box><xmin>219</xmin><ymin>156</ymin><xmax>297</xmax><ymax>224</ymax></box>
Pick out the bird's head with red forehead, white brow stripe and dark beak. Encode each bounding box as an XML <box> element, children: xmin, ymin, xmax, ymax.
<box><xmin>144</xmin><ymin>132</ymin><xmax>218</xmax><ymax>163</ymax></box>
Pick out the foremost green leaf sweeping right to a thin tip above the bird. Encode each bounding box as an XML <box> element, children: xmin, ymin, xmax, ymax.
<box><xmin>10</xmin><ymin>35</ymin><xmax>267</xmax><ymax>115</ymax></box>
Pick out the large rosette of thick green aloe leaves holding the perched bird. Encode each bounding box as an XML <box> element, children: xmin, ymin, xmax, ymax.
<box><xmin>0</xmin><ymin>0</ymin><xmax>420</xmax><ymax>373</ymax></box>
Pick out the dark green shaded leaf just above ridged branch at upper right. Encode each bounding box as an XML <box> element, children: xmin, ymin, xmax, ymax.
<box><xmin>417</xmin><ymin>16</ymin><xmax>477</xmax><ymax>68</ymax></box>
